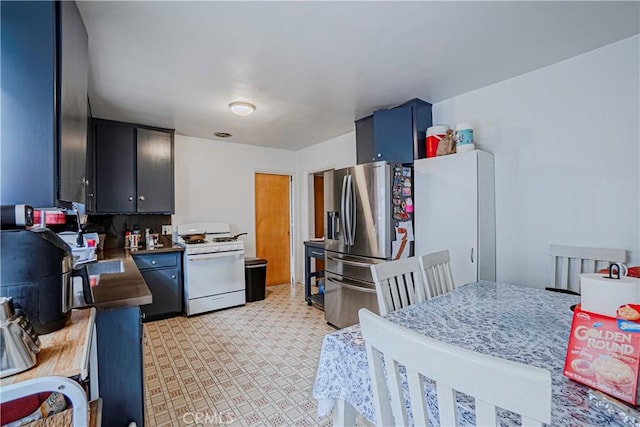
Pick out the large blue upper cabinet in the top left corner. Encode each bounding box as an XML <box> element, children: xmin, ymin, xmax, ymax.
<box><xmin>0</xmin><ymin>1</ymin><xmax>88</xmax><ymax>207</ymax></box>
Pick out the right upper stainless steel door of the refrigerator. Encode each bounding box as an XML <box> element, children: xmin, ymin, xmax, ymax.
<box><xmin>346</xmin><ymin>162</ymin><xmax>393</xmax><ymax>259</ymax></box>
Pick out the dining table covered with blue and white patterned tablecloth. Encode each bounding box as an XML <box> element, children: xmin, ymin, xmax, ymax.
<box><xmin>313</xmin><ymin>281</ymin><xmax>626</xmax><ymax>426</ymax></box>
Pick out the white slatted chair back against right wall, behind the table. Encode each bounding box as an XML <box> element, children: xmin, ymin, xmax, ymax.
<box><xmin>549</xmin><ymin>245</ymin><xmax>627</xmax><ymax>292</ymax></box>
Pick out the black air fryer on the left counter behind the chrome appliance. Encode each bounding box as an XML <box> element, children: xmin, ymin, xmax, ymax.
<box><xmin>0</xmin><ymin>228</ymin><xmax>75</xmax><ymax>335</ymax></box>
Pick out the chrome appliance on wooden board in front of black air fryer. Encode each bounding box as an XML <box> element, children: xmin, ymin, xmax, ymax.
<box><xmin>0</xmin><ymin>297</ymin><xmax>40</xmax><ymax>378</ymax></box>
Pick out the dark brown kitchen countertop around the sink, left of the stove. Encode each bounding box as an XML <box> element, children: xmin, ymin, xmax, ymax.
<box><xmin>82</xmin><ymin>245</ymin><xmax>184</xmax><ymax>310</ymax></box>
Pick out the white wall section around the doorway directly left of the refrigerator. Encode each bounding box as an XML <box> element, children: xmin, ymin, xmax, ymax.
<box><xmin>294</xmin><ymin>131</ymin><xmax>356</xmax><ymax>283</ymax></box>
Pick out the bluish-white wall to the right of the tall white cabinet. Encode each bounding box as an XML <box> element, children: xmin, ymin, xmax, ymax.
<box><xmin>433</xmin><ymin>36</ymin><xmax>640</xmax><ymax>287</ymax></box>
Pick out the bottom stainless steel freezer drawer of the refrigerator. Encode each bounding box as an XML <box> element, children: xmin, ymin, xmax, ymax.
<box><xmin>324</xmin><ymin>273</ymin><xmax>379</xmax><ymax>328</ymax></box>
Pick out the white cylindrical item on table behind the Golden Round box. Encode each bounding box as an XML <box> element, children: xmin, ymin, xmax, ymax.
<box><xmin>580</xmin><ymin>273</ymin><xmax>640</xmax><ymax>317</ymax></box>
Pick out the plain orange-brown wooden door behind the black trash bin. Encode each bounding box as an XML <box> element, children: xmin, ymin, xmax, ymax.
<box><xmin>255</xmin><ymin>173</ymin><xmax>291</xmax><ymax>286</ymax></box>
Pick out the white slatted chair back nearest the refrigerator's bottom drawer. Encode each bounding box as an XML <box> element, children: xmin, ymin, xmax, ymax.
<box><xmin>371</xmin><ymin>257</ymin><xmax>426</xmax><ymax>316</ymax></box>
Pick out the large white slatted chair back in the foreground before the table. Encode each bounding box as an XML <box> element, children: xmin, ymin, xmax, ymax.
<box><xmin>358</xmin><ymin>309</ymin><xmax>551</xmax><ymax>426</ymax></box>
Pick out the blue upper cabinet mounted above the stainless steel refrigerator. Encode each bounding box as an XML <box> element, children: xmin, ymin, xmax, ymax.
<box><xmin>356</xmin><ymin>99</ymin><xmax>432</xmax><ymax>164</ymax></box>
